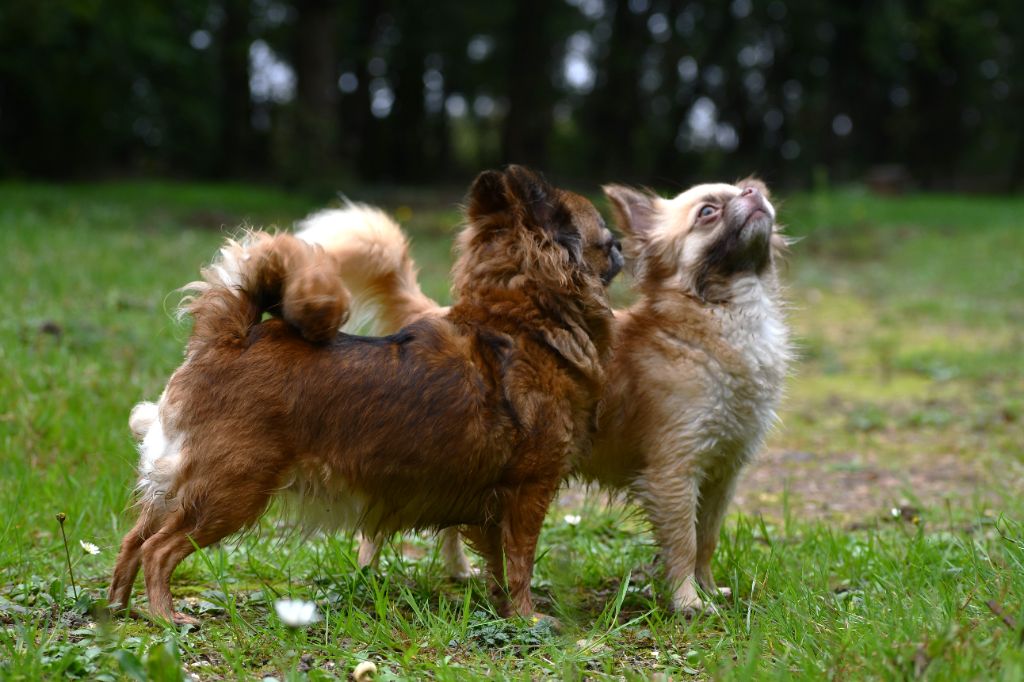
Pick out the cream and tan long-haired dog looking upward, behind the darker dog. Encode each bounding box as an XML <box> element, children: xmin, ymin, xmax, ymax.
<box><xmin>299</xmin><ymin>175</ymin><xmax>791</xmax><ymax>613</ymax></box>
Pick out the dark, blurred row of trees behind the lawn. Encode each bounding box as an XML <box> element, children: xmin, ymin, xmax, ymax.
<box><xmin>0</xmin><ymin>0</ymin><xmax>1024</xmax><ymax>190</ymax></box>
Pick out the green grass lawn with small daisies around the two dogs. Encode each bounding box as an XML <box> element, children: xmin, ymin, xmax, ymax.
<box><xmin>0</xmin><ymin>178</ymin><xmax>1024</xmax><ymax>680</ymax></box>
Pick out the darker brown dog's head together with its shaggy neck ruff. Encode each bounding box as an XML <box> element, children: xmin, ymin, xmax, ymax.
<box><xmin>453</xmin><ymin>166</ymin><xmax>623</xmax><ymax>382</ymax></box>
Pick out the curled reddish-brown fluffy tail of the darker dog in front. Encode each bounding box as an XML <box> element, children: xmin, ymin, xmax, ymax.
<box><xmin>182</xmin><ymin>232</ymin><xmax>349</xmax><ymax>352</ymax></box>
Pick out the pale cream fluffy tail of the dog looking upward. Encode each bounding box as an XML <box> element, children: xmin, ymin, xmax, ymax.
<box><xmin>296</xmin><ymin>202</ymin><xmax>445</xmax><ymax>334</ymax></box>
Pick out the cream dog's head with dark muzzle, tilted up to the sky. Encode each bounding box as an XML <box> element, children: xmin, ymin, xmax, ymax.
<box><xmin>604</xmin><ymin>178</ymin><xmax>785</xmax><ymax>301</ymax></box>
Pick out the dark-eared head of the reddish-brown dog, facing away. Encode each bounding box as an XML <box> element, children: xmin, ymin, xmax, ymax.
<box><xmin>454</xmin><ymin>166</ymin><xmax>623</xmax><ymax>294</ymax></box>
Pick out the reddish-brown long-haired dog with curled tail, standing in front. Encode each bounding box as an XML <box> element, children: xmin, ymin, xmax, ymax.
<box><xmin>110</xmin><ymin>167</ymin><xmax>622</xmax><ymax>623</ymax></box>
